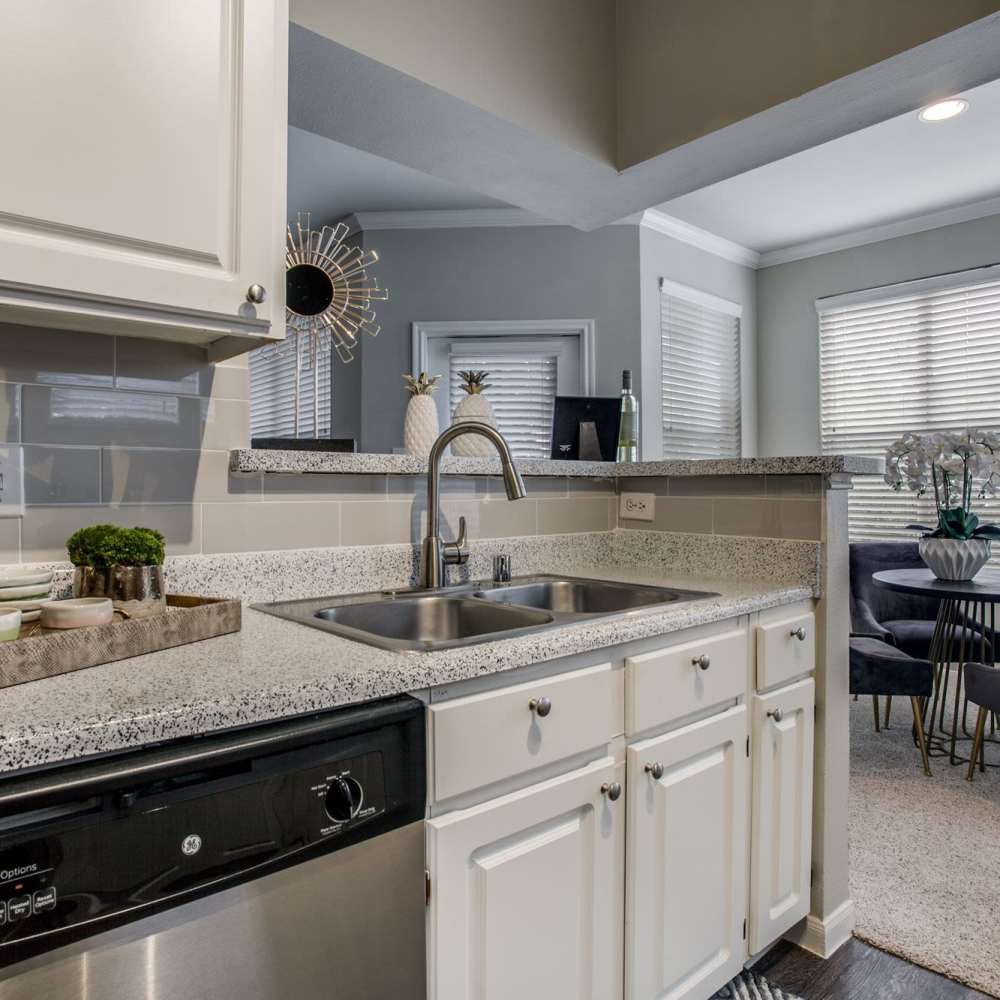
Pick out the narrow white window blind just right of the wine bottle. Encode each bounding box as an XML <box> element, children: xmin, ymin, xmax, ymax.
<box><xmin>660</xmin><ymin>282</ymin><xmax>742</xmax><ymax>458</ymax></box>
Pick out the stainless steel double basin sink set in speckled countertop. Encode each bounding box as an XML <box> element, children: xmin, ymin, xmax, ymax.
<box><xmin>254</xmin><ymin>575</ymin><xmax>716</xmax><ymax>652</ymax></box>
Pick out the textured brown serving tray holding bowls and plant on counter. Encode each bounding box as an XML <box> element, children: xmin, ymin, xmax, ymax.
<box><xmin>0</xmin><ymin>594</ymin><xmax>243</xmax><ymax>688</ymax></box>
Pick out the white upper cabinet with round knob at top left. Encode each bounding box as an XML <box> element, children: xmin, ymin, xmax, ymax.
<box><xmin>0</xmin><ymin>0</ymin><xmax>288</xmax><ymax>354</ymax></box>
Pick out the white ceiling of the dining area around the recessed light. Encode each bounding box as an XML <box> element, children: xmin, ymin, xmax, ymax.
<box><xmin>657</xmin><ymin>80</ymin><xmax>1000</xmax><ymax>253</ymax></box>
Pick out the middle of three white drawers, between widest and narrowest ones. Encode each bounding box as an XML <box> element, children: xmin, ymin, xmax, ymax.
<box><xmin>625</xmin><ymin>628</ymin><xmax>747</xmax><ymax>733</ymax></box>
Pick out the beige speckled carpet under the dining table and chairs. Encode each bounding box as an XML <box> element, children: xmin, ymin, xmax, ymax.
<box><xmin>850</xmin><ymin>697</ymin><xmax>1000</xmax><ymax>997</ymax></box>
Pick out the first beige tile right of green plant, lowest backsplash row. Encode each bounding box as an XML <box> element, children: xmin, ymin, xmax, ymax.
<box><xmin>201</xmin><ymin>502</ymin><xmax>340</xmax><ymax>553</ymax></box>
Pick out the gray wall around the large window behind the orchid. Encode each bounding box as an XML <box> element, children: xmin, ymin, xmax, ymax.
<box><xmin>757</xmin><ymin>215</ymin><xmax>1000</xmax><ymax>455</ymax></box>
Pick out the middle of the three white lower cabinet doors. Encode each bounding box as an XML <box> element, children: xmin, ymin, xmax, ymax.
<box><xmin>625</xmin><ymin>705</ymin><xmax>748</xmax><ymax>1000</ymax></box>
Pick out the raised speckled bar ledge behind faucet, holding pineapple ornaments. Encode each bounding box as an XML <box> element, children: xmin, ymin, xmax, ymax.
<box><xmin>229</xmin><ymin>448</ymin><xmax>884</xmax><ymax>479</ymax></box>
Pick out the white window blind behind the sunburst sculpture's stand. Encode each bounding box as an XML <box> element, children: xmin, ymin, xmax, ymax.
<box><xmin>250</xmin><ymin>345</ymin><xmax>333</xmax><ymax>437</ymax></box>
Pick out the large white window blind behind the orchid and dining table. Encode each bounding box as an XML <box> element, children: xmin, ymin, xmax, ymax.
<box><xmin>816</xmin><ymin>275</ymin><xmax>1000</xmax><ymax>540</ymax></box>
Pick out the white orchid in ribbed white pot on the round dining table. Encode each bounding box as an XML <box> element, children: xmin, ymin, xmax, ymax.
<box><xmin>885</xmin><ymin>428</ymin><xmax>1000</xmax><ymax>580</ymax></box>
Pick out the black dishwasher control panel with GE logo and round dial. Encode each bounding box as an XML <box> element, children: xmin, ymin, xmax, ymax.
<box><xmin>0</xmin><ymin>698</ymin><xmax>426</xmax><ymax>966</ymax></box>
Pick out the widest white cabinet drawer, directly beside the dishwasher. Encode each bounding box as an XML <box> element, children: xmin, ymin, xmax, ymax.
<box><xmin>430</xmin><ymin>663</ymin><xmax>622</xmax><ymax>801</ymax></box>
